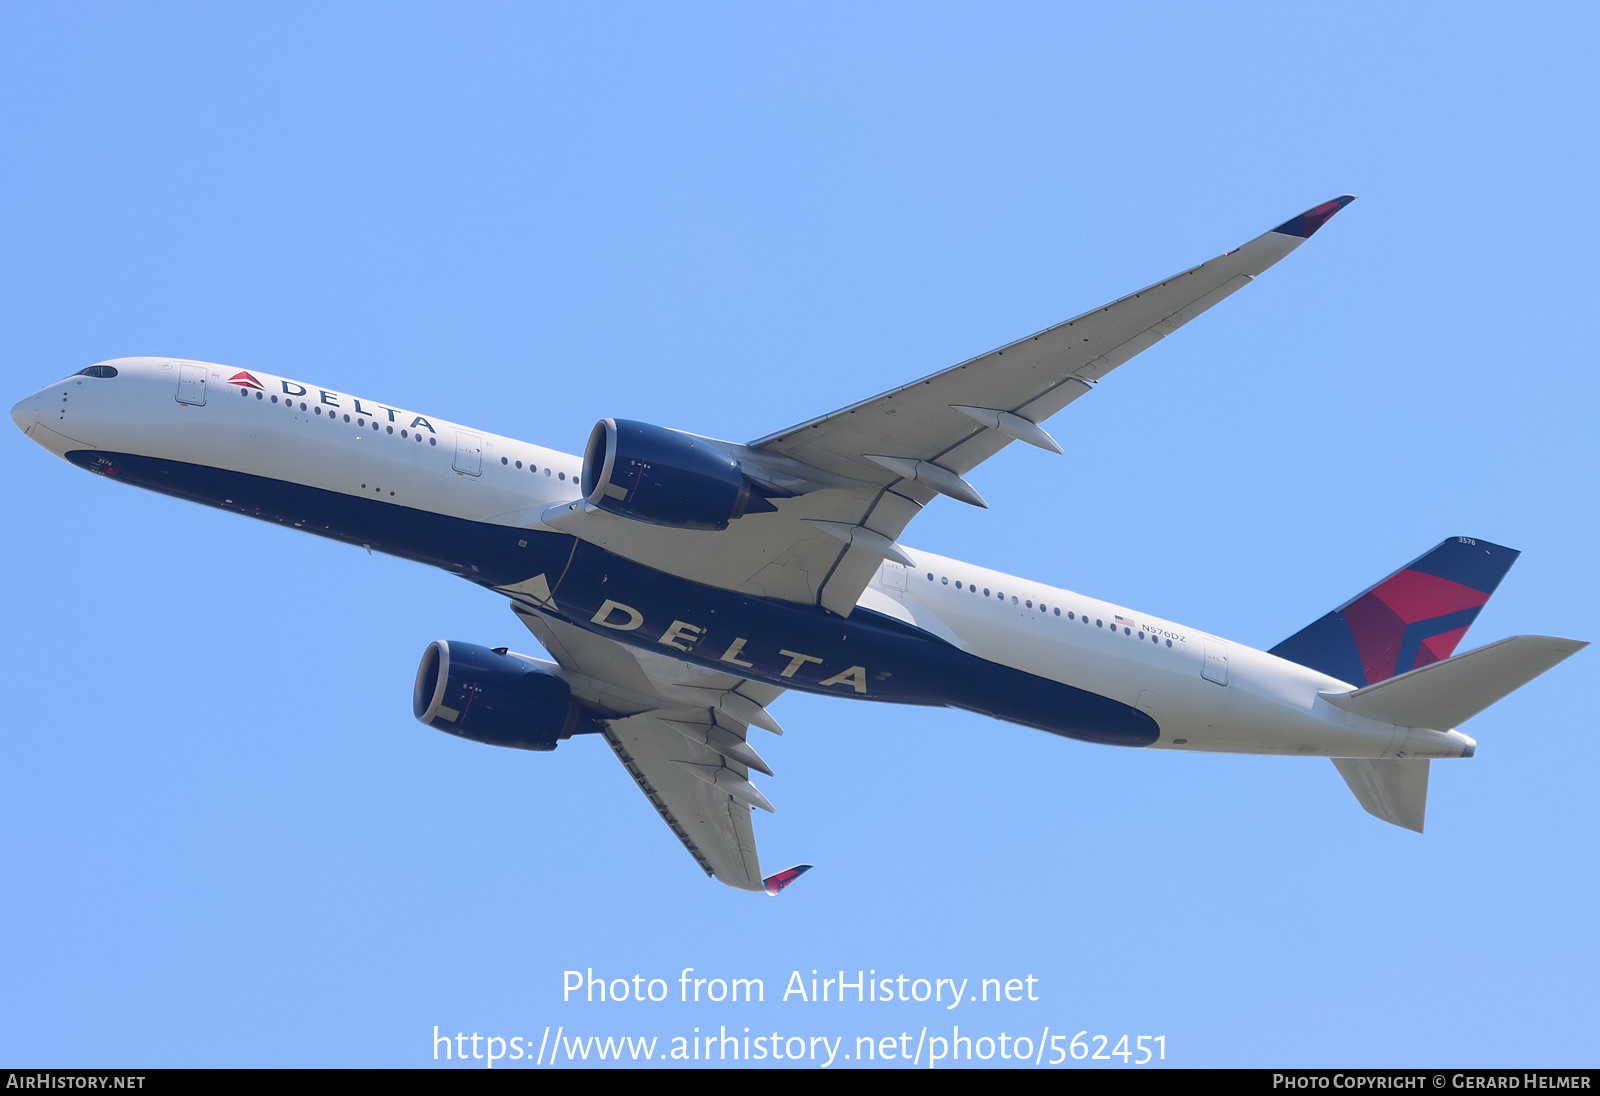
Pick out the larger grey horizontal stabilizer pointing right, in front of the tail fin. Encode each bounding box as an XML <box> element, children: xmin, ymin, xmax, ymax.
<box><xmin>1322</xmin><ymin>635</ymin><xmax>1589</xmax><ymax>726</ymax></box>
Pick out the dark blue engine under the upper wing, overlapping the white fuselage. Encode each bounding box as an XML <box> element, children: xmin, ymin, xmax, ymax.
<box><xmin>581</xmin><ymin>419</ymin><xmax>776</xmax><ymax>530</ymax></box>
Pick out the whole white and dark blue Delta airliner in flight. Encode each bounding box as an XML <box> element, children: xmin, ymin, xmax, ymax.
<box><xmin>11</xmin><ymin>195</ymin><xmax>1587</xmax><ymax>894</ymax></box>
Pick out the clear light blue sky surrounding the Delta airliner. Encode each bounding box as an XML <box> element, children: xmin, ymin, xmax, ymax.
<box><xmin>0</xmin><ymin>3</ymin><xmax>1600</xmax><ymax>1067</ymax></box>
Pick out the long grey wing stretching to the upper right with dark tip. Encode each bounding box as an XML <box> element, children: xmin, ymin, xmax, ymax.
<box><xmin>541</xmin><ymin>195</ymin><xmax>1354</xmax><ymax>616</ymax></box>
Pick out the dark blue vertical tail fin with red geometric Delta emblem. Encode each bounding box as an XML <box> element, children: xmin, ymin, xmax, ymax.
<box><xmin>1270</xmin><ymin>536</ymin><xmax>1520</xmax><ymax>688</ymax></box>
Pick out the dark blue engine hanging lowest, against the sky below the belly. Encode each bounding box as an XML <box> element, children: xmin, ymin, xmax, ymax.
<box><xmin>411</xmin><ymin>640</ymin><xmax>598</xmax><ymax>750</ymax></box>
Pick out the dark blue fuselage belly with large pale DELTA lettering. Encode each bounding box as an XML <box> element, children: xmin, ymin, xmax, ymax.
<box><xmin>67</xmin><ymin>451</ymin><xmax>1160</xmax><ymax>746</ymax></box>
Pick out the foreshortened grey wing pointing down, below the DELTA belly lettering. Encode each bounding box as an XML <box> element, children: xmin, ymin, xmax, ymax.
<box><xmin>512</xmin><ymin>602</ymin><xmax>787</xmax><ymax>893</ymax></box>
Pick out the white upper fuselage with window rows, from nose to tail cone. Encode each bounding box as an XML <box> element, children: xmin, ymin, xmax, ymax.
<box><xmin>13</xmin><ymin>358</ymin><xmax>1472</xmax><ymax>758</ymax></box>
